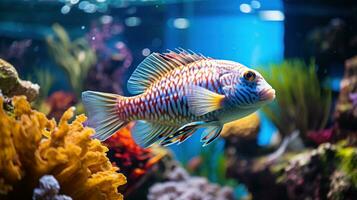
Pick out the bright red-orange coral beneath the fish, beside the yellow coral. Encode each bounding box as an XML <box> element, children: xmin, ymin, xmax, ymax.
<box><xmin>105</xmin><ymin>124</ymin><xmax>167</xmax><ymax>194</ymax></box>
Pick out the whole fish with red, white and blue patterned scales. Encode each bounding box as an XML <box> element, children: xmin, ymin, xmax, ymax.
<box><xmin>82</xmin><ymin>49</ymin><xmax>275</xmax><ymax>147</ymax></box>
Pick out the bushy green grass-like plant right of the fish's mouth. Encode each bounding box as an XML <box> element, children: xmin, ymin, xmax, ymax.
<box><xmin>259</xmin><ymin>59</ymin><xmax>331</xmax><ymax>141</ymax></box>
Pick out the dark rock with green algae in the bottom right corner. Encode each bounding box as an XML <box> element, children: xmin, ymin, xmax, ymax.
<box><xmin>279</xmin><ymin>143</ymin><xmax>357</xmax><ymax>200</ymax></box>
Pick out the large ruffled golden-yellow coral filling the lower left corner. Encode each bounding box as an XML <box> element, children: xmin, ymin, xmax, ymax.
<box><xmin>0</xmin><ymin>97</ymin><xmax>126</xmax><ymax>199</ymax></box>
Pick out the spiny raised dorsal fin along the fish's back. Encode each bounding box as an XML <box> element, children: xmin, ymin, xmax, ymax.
<box><xmin>128</xmin><ymin>49</ymin><xmax>208</xmax><ymax>94</ymax></box>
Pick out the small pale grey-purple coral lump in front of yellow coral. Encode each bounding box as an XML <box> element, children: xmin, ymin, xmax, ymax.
<box><xmin>32</xmin><ymin>175</ymin><xmax>72</xmax><ymax>200</ymax></box>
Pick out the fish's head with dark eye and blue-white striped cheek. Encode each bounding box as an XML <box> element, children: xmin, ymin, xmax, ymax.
<box><xmin>221</xmin><ymin>65</ymin><xmax>275</xmax><ymax>108</ymax></box>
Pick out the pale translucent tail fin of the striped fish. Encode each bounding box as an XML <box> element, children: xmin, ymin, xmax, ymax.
<box><xmin>82</xmin><ymin>91</ymin><xmax>128</xmax><ymax>141</ymax></box>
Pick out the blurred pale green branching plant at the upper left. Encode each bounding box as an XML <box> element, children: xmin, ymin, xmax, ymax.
<box><xmin>46</xmin><ymin>24</ymin><xmax>96</xmax><ymax>96</ymax></box>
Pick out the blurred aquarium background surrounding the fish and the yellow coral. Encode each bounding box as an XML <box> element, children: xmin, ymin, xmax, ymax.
<box><xmin>0</xmin><ymin>0</ymin><xmax>357</xmax><ymax>199</ymax></box>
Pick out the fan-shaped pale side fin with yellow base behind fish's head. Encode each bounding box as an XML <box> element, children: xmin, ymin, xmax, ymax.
<box><xmin>186</xmin><ymin>85</ymin><xmax>225</xmax><ymax>116</ymax></box>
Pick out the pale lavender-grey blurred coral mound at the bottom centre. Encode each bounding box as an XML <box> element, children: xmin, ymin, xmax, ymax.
<box><xmin>148</xmin><ymin>166</ymin><xmax>234</xmax><ymax>200</ymax></box>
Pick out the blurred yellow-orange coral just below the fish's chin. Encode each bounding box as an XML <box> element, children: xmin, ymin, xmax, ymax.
<box><xmin>221</xmin><ymin>113</ymin><xmax>260</xmax><ymax>138</ymax></box>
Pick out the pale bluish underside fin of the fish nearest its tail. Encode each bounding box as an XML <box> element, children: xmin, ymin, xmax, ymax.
<box><xmin>132</xmin><ymin>120</ymin><xmax>177</xmax><ymax>148</ymax></box>
